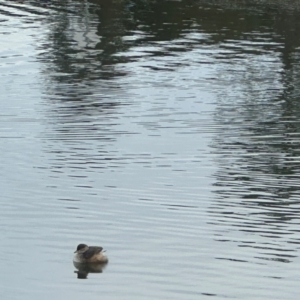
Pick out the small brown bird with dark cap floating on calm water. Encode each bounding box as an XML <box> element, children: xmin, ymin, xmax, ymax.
<box><xmin>73</xmin><ymin>244</ymin><xmax>108</xmax><ymax>263</ymax></box>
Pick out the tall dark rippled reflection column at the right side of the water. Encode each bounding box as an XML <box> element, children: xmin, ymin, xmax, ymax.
<box><xmin>210</xmin><ymin>37</ymin><xmax>300</xmax><ymax>262</ymax></box>
